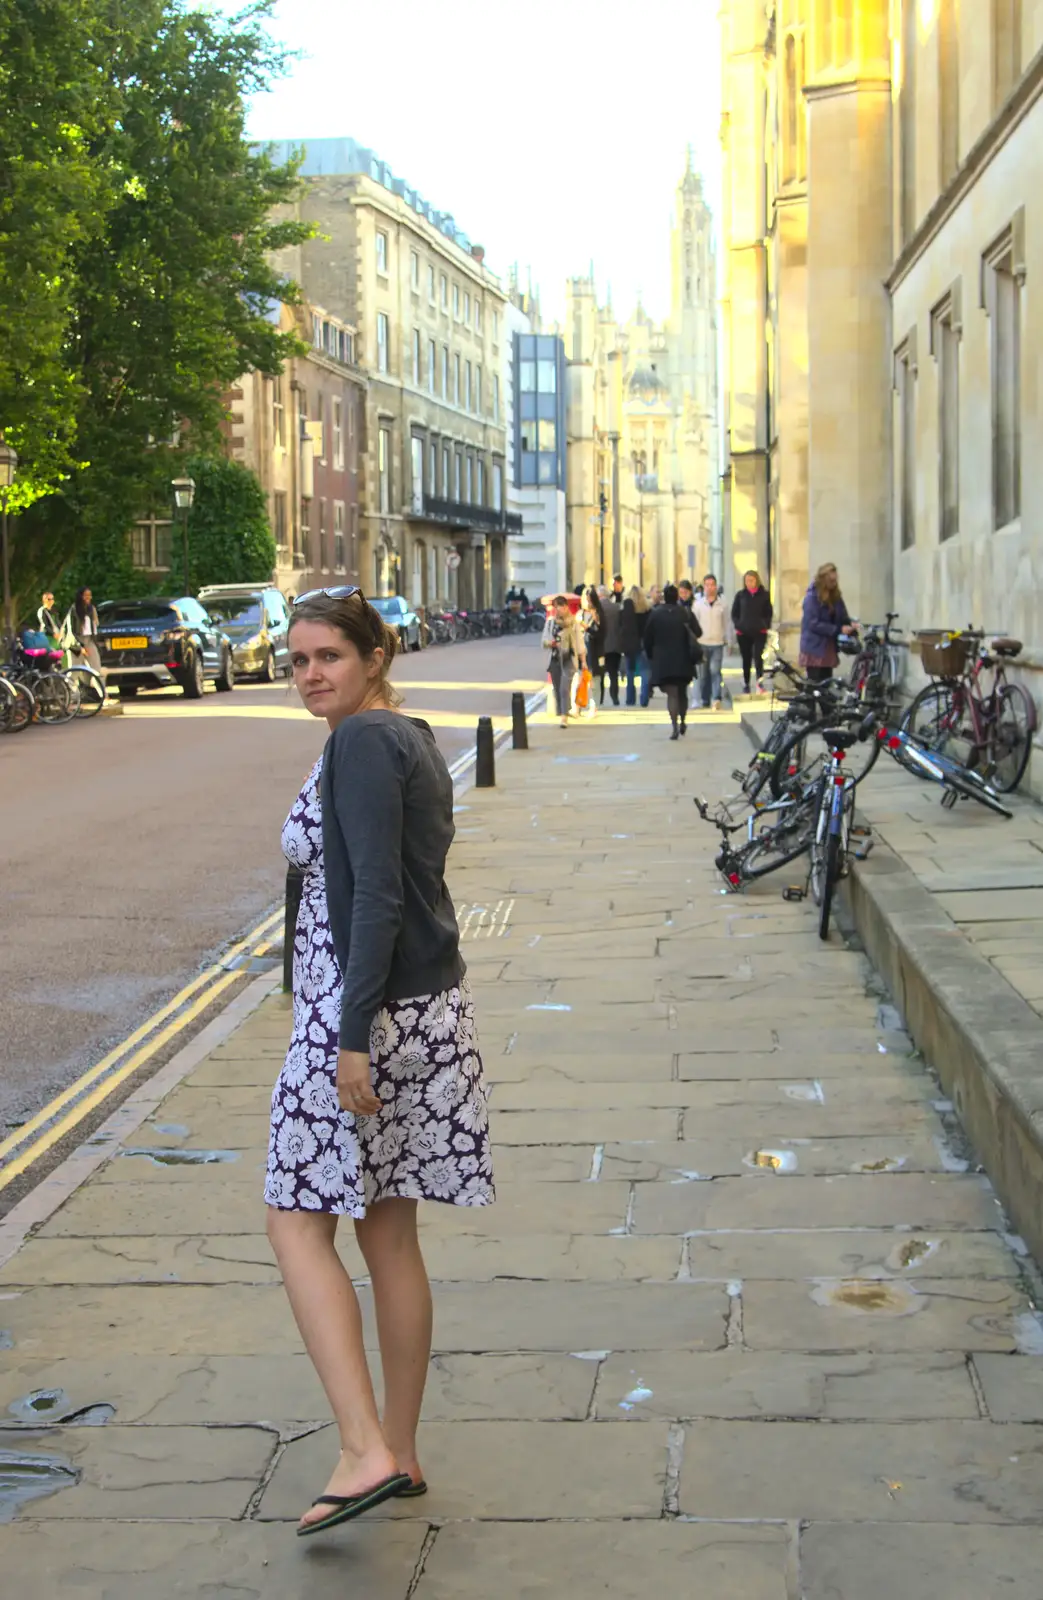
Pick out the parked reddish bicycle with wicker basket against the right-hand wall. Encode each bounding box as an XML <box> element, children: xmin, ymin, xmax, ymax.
<box><xmin>902</xmin><ymin>627</ymin><xmax>1037</xmax><ymax>794</ymax></box>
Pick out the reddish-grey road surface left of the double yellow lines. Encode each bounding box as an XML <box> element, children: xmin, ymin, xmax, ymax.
<box><xmin>0</xmin><ymin>635</ymin><xmax>542</xmax><ymax>1152</ymax></box>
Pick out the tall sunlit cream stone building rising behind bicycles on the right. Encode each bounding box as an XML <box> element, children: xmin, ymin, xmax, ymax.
<box><xmin>721</xmin><ymin>0</ymin><xmax>1043</xmax><ymax>758</ymax></box>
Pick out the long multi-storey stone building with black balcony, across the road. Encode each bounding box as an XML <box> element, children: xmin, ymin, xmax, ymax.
<box><xmin>255</xmin><ymin>139</ymin><xmax>520</xmax><ymax>610</ymax></box>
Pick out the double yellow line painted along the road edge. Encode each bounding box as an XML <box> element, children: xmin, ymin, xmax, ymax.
<box><xmin>0</xmin><ymin>909</ymin><xmax>283</xmax><ymax>1189</ymax></box>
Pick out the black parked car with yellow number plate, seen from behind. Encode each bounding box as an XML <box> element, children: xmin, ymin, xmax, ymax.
<box><xmin>98</xmin><ymin>595</ymin><xmax>235</xmax><ymax>699</ymax></box>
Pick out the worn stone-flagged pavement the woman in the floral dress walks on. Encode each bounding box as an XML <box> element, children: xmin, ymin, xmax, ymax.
<box><xmin>0</xmin><ymin>709</ymin><xmax>1043</xmax><ymax>1600</ymax></box>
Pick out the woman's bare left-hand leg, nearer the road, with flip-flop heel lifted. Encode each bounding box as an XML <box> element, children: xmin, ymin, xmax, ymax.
<box><xmin>267</xmin><ymin>1206</ymin><xmax>395</xmax><ymax>1523</ymax></box>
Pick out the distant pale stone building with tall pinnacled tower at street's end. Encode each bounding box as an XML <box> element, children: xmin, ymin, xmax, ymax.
<box><xmin>563</xmin><ymin>155</ymin><xmax>720</xmax><ymax>587</ymax></box>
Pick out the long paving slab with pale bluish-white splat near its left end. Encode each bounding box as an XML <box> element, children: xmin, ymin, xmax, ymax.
<box><xmin>597</xmin><ymin>1350</ymin><xmax>981</xmax><ymax>1422</ymax></box>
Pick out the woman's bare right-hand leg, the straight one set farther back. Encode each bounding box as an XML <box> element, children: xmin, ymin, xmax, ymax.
<box><xmin>355</xmin><ymin>1200</ymin><xmax>432</xmax><ymax>1483</ymax></box>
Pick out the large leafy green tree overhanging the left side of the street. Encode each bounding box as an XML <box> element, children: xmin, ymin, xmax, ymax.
<box><xmin>0</xmin><ymin>0</ymin><xmax>306</xmax><ymax>617</ymax></box>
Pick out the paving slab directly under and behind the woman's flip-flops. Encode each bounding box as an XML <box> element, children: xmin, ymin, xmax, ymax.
<box><xmin>259</xmin><ymin>1422</ymin><xmax>667</xmax><ymax>1523</ymax></box>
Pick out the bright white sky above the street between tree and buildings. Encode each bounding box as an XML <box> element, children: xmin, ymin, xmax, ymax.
<box><xmin>225</xmin><ymin>0</ymin><xmax>720</xmax><ymax>318</ymax></box>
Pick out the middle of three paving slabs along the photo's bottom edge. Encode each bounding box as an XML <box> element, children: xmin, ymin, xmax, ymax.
<box><xmin>416</xmin><ymin>1522</ymin><xmax>789</xmax><ymax>1600</ymax></box>
